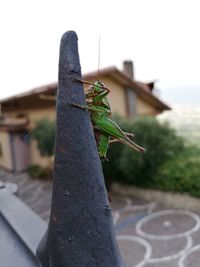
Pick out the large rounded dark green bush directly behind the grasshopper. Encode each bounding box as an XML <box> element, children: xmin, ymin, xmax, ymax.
<box><xmin>103</xmin><ymin>117</ymin><xmax>184</xmax><ymax>187</ymax></box>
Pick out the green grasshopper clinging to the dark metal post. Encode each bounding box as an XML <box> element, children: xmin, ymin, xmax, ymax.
<box><xmin>71</xmin><ymin>80</ymin><xmax>145</xmax><ymax>159</ymax></box>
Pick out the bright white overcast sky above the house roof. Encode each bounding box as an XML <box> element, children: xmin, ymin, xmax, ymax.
<box><xmin>0</xmin><ymin>0</ymin><xmax>200</xmax><ymax>106</ymax></box>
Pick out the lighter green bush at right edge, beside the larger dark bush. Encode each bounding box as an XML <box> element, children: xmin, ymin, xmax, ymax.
<box><xmin>152</xmin><ymin>147</ymin><xmax>200</xmax><ymax>197</ymax></box>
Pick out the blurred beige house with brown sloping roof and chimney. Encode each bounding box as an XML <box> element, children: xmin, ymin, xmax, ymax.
<box><xmin>0</xmin><ymin>61</ymin><xmax>170</xmax><ymax>171</ymax></box>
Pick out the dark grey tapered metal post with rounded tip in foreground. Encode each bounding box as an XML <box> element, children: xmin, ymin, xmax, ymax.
<box><xmin>38</xmin><ymin>32</ymin><xmax>124</xmax><ymax>267</ymax></box>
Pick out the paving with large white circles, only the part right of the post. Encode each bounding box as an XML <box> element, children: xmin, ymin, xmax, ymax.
<box><xmin>113</xmin><ymin>198</ymin><xmax>200</xmax><ymax>267</ymax></box>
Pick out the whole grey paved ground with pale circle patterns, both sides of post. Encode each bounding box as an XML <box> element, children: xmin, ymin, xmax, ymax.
<box><xmin>0</xmin><ymin>170</ymin><xmax>200</xmax><ymax>267</ymax></box>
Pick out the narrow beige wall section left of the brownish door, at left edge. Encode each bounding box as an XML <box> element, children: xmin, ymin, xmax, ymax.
<box><xmin>0</xmin><ymin>131</ymin><xmax>12</xmax><ymax>170</ymax></box>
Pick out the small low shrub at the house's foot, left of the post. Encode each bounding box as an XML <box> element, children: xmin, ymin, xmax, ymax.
<box><xmin>26</xmin><ymin>164</ymin><xmax>52</xmax><ymax>178</ymax></box>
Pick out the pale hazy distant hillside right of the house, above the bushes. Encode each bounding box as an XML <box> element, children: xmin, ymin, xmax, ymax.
<box><xmin>157</xmin><ymin>104</ymin><xmax>200</xmax><ymax>145</ymax></box>
